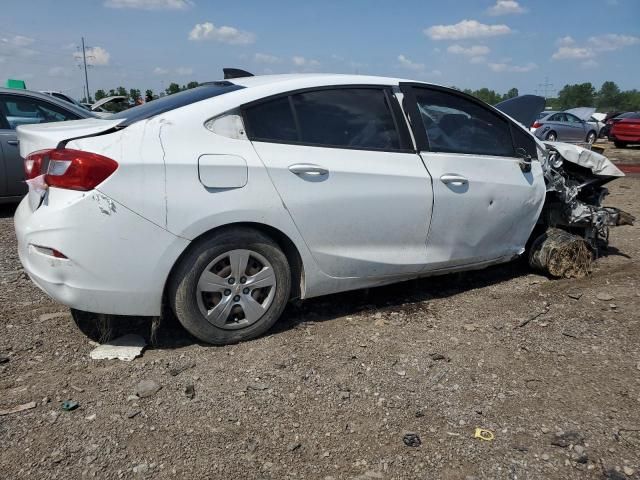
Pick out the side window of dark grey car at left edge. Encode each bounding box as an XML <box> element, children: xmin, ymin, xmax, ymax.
<box><xmin>0</xmin><ymin>95</ymin><xmax>79</xmax><ymax>130</ymax></box>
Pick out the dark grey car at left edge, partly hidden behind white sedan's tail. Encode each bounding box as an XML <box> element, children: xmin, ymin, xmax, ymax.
<box><xmin>0</xmin><ymin>88</ymin><xmax>95</xmax><ymax>203</ymax></box>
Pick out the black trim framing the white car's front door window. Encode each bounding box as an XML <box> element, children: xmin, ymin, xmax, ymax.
<box><xmin>400</xmin><ymin>82</ymin><xmax>537</xmax><ymax>160</ymax></box>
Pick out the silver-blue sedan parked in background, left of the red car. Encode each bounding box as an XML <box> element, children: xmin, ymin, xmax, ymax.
<box><xmin>531</xmin><ymin>111</ymin><xmax>598</xmax><ymax>143</ymax></box>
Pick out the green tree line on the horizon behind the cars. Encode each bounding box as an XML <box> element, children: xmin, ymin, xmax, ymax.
<box><xmin>87</xmin><ymin>81</ymin><xmax>640</xmax><ymax>112</ymax></box>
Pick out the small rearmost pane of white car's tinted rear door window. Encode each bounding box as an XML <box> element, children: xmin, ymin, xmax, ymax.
<box><xmin>245</xmin><ymin>97</ymin><xmax>298</xmax><ymax>142</ymax></box>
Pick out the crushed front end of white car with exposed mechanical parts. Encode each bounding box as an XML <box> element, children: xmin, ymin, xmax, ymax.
<box><xmin>538</xmin><ymin>142</ymin><xmax>635</xmax><ymax>256</ymax></box>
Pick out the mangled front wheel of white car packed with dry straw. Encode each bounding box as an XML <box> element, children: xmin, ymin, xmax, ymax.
<box><xmin>529</xmin><ymin>228</ymin><xmax>593</xmax><ymax>278</ymax></box>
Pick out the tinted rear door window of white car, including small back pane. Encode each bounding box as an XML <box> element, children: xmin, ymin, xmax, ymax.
<box><xmin>244</xmin><ymin>88</ymin><xmax>400</xmax><ymax>150</ymax></box>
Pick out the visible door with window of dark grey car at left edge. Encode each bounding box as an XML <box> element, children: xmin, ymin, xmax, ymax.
<box><xmin>0</xmin><ymin>94</ymin><xmax>79</xmax><ymax>196</ymax></box>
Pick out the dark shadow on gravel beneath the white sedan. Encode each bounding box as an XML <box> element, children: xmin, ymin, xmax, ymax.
<box><xmin>148</xmin><ymin>259</ymin><xmax>532</xmax><ymax>349</ymax></box>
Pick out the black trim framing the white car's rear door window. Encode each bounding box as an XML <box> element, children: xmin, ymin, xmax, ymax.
<box><xmin>240</xmin><ymin>83</ymin><xmax>417</xmax><ymax>154</ymax></box>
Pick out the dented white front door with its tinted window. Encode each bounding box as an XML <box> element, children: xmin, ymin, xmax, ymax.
<box><xmin>402</xmin><ymin>85</ymin><xmax>545</xmax><ymax>270</ymax></box>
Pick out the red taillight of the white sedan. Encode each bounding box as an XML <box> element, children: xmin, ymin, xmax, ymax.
<box><xmin>24</xmin><ymin>148</ymin><xmax>118</xmax><ymax>191</ymax></box>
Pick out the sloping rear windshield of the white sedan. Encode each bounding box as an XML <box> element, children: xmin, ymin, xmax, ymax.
<box><xmin>109</xmin><ymin>82</ymin><xmax>244</xmax><ymax>127</ymax></box>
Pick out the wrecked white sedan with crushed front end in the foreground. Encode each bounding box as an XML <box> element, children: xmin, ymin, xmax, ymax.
<box><xmin>15</xmin><ymin>71</ymin><xmax>632</xmax><ymax>344</ymax></box>
